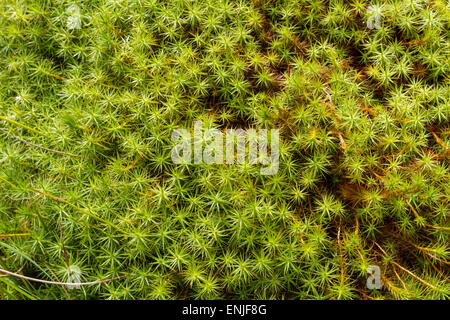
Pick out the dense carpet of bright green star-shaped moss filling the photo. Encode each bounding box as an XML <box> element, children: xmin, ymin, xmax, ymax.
<box><xmin>0</xmin><ymin>0</ymin><xmax>450</xmax><ymax>299</ymax></box>
